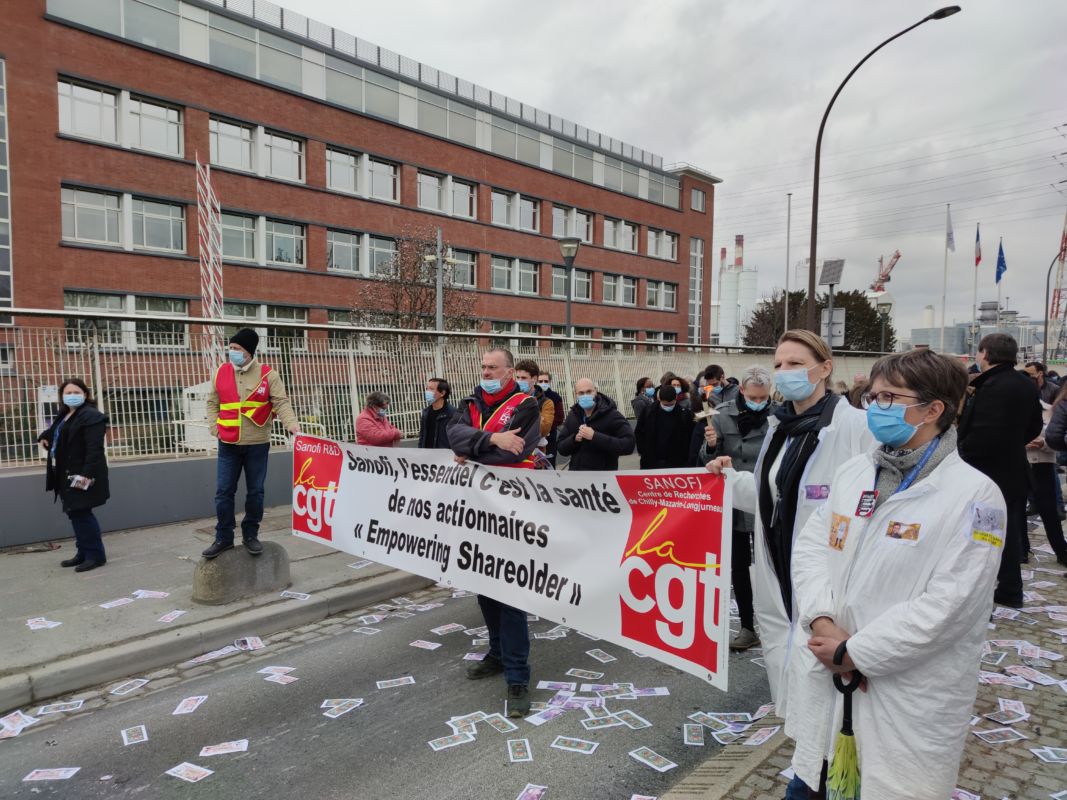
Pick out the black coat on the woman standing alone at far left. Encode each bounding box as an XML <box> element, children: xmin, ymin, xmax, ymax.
<box><xmin>37</xmin><ymin>405</ymin><xmax>111</xmax><ymax>511</ymax></box>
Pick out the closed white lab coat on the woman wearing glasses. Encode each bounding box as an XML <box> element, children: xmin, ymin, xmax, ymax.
<box><xmin>786</xmin><ymin>451</ymin><xmax>1006</xmax><ymax>800</ymax></box>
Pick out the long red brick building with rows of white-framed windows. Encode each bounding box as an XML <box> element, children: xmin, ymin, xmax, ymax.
<box><xmin>0</xmin><ymin>0</ymin><xmax>718</xmax><ymax>347</ymax></box>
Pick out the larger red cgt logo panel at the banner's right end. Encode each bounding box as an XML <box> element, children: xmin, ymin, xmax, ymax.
<box><xmin>618</xmin><ymin>475</ymin><xmax>722</xmax><ymax>673</ymax></box>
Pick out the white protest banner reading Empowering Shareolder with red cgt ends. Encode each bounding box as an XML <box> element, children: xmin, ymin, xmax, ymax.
<box><xmin>292</xmin><ymin>435</ymin><xmax>732</xmax><ymax>691</ymax></box>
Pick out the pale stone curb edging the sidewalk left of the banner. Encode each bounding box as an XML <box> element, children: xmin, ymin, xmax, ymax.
<box><xmin>0</xmin><ymin>570</ymin><xmax>434</xmax><ymax>709</ymax></box>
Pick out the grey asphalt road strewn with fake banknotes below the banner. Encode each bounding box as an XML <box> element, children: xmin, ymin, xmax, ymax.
<box><xmin>0</xmin><ymin>590</ymin><xmax>768</xmax><ymax>800</ymax></box>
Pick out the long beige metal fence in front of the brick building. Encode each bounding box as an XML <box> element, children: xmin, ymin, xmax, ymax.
<box><xmin>0</xmin><ymin>313</ymin><xmax>874</xmax><ymax>467</ymax></box>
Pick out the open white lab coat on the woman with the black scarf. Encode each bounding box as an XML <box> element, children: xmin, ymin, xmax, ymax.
<box><xmin>727</xmin><ymin>398</ymin><xmax>875</xmax><ymax>721</ymax></box>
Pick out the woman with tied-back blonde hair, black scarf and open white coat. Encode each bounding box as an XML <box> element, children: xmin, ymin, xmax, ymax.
<box><xmin>707</xmin><ymin>331</ymin><xmax>874</xmax><ymax>733</ymax></box>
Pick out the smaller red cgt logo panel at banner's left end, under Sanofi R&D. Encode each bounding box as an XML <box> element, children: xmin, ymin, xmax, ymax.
<box><xmin>292</xmin><ymin>435</ymin><xmax>344</xmax><ymax>541</ymax></box>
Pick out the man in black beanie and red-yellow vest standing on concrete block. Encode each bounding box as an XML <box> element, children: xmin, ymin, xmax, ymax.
<box><xmin>201</xmin><ymin>327</ymin><xmax>300</xmax><ymax>558</ymax></box>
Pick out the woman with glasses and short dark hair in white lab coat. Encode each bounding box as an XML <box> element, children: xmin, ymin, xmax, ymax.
<box><xmin>786</xmin><ymin>350</ymin><xmax>1006</xmax><ymax>800</ymax></box>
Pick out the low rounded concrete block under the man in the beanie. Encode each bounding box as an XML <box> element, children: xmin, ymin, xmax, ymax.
<box><xmin>193</xmin><ymin>542</ymin><xmax>289</xmax><ymax>606</ymax></box>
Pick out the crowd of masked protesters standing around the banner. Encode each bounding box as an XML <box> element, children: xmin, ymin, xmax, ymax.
<box><xmin>38</xmin><ymin>329</ymin><xmax>1067</xmax><ymax>800</ymax></box>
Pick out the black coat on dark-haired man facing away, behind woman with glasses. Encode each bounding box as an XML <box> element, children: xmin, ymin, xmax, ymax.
<box><xmin>958</xmin><ymin>364</ymin><xmax>1051</xmax><ymax>502</ymax></box>
